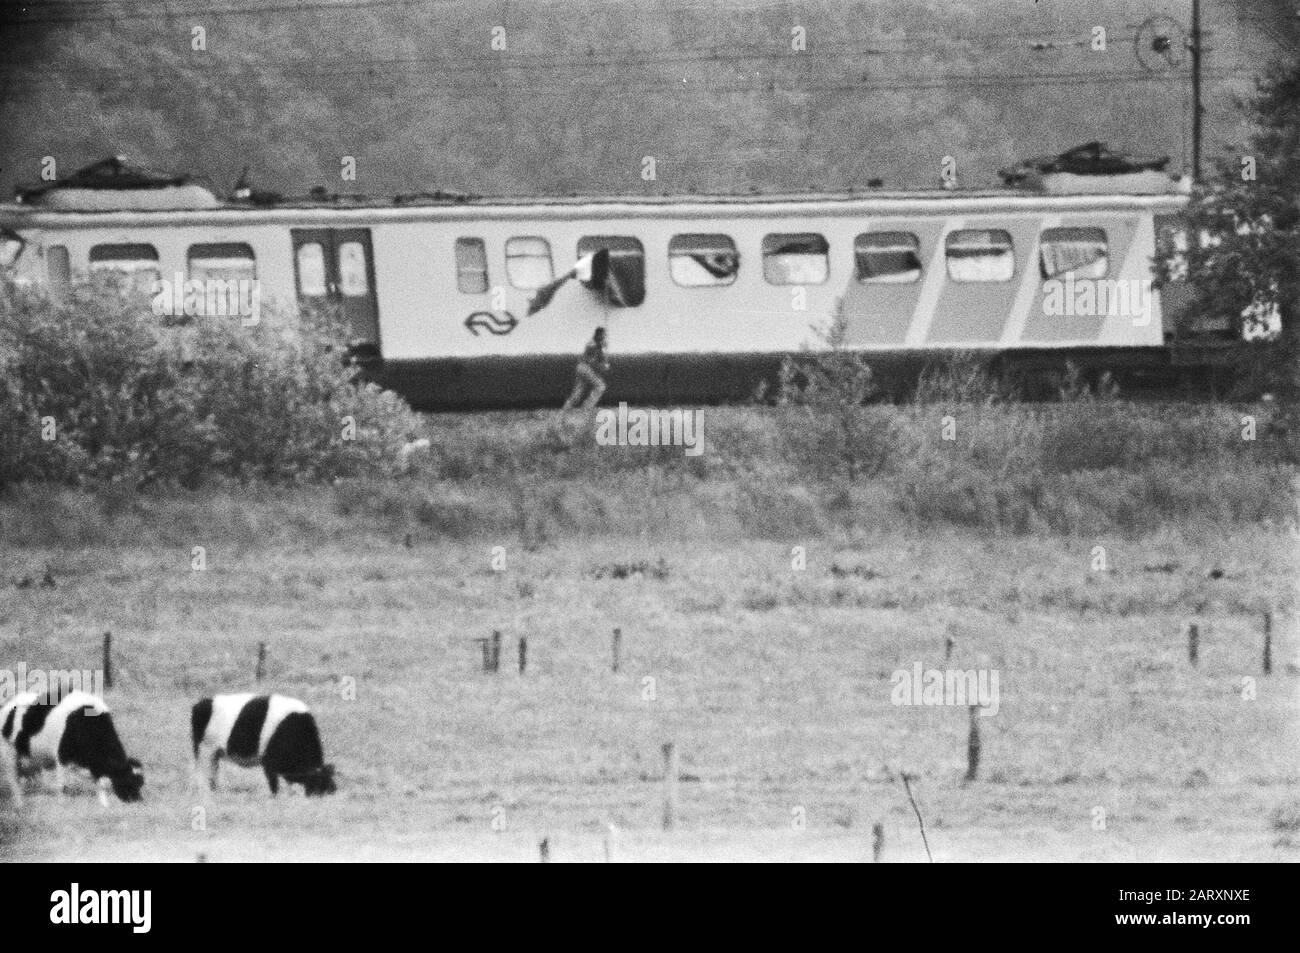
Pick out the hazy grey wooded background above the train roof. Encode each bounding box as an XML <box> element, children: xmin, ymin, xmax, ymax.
<box><xmin>0</xmin><ymin>0</ymin><xmax>1291</xmax><ymax>195</ymax></box>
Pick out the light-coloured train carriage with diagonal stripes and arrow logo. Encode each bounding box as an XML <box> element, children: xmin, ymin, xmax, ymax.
<box><xmin>0</xmin><ymin>159</ymin><xmax>1187</xmax><ymax>408</ymax></box>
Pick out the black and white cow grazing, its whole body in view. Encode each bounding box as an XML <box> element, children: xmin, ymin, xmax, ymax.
<box><xmin>190</xmin><ymin>693</ymin><xmax>334</xmax><ymax>796</ymax></box>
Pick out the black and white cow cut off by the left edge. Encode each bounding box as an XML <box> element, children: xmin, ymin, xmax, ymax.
<box><xmin>0</xmin><ymin>692</ymin><xmax>144</xmax><ymax>805</ymax></box>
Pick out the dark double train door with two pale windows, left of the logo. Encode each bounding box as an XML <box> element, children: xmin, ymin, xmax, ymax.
<box><xmin>291</xmin><ymin>229</ymin><xmax>380</xmax><ymax>348</ymax></box>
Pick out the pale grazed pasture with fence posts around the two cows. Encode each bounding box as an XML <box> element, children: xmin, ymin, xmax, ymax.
<box><xmin>0</xmin><ymin>520</ymin><xmax>1300</xmax><ymax>862</ymax></box>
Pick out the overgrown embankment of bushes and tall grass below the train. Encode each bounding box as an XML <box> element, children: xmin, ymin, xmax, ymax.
<box><xmin>0</xmin><ymin>278</ymin><xmax>1300</xmax><ymax>547</ymax></box>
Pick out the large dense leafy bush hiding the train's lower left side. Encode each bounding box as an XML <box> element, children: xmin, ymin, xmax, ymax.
<box><xmin>0</xmin><ymin>273</ymin><xmax>419</xmax><ymax>488</ymax></box>
